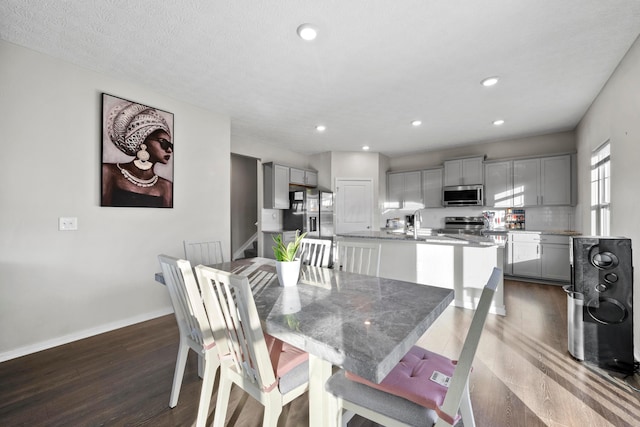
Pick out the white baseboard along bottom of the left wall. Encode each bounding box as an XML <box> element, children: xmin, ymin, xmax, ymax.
<box><xmin>0</xmin><ymin>307</ymin><xmax>173</xmax><ymax>362</ymax></box>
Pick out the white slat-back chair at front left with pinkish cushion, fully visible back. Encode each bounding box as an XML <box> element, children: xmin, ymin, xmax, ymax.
<box><xmin>196</xmin><ymin>265</ymin><xmax>309</xmax><ymax>427</ymax></box>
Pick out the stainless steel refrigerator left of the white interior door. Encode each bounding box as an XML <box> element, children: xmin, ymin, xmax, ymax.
<box><xmin>282</xmin><ymin>188</ymin><xmax>334</xmax><ymax>238</ymax></box>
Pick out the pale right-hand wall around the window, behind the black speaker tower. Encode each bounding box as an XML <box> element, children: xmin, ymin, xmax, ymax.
<box><xmin>576</xmin><ymin>39</ymin><xmax>640</xmax><ymax>359</ymax></box>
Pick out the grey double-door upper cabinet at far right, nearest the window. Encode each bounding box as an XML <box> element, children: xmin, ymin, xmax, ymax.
<box><xmin>513</xmin><ymin>154</ymin><xmax>572</xmax><ymax>206</ymax></box>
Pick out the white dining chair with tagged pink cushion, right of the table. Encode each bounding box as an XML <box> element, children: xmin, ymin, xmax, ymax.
<box><xmin>326</xmin><ymin>268</ymin><xmax>502</xmax><ymax>427</ymax></box>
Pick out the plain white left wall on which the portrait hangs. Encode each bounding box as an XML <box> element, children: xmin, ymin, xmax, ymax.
<box><xmin>0</xmin><ymin>41</ymin><xmax>230</xmax><ymax>361</ymax></box>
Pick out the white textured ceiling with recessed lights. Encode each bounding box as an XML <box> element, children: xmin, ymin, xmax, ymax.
<box><xmin>0</xmin><ymin>0</ymin><xmax>640</xmax><ymax>157</ymax></box>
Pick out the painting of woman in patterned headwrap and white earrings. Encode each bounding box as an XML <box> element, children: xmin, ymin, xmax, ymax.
<box><xmin>100</xmin><ymin>93</ymin><xmax>173</xmax><ymax>208</ymax></box>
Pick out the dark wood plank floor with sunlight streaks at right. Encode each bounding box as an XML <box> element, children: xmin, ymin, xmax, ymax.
<box><xmin>0</xmin><ymin>281</ymin><xmax>640</xmax><ymax>427</ymax></box>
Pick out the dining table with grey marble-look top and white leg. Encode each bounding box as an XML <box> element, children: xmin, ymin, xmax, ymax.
<box><xmin>156</xmin><ymin>257</ymin><xmax>454</xmax><ymax>427</ymax></box>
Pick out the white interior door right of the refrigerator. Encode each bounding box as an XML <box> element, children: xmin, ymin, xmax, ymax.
<box><xmin>335</xmin><ymin>179</ymin><xmax>373</xmax><ymax>234</ymax></box>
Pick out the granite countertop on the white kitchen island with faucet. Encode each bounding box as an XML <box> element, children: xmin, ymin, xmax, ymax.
<box><xmin>338</xmin><ymin>228</ymin><xmax>504</xmax><ymax>246</ymax></box>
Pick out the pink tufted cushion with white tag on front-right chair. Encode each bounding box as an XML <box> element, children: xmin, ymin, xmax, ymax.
<box><xmin>346</xmin><ymin>346</ymin><xmax>460</xmax><ymax>425</ymax></box>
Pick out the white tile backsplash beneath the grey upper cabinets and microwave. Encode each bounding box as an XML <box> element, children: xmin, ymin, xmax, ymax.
<box><xmin>380</xmin><ymin>206</ymin><xmax>577</xmax><ymax>231</ymax></box>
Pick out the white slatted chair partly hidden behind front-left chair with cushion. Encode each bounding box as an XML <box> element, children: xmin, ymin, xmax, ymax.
<box><xmin>158</xmin><ymin>255</ymin><xmax>220</xmax><ymax>420</ymax></box>
